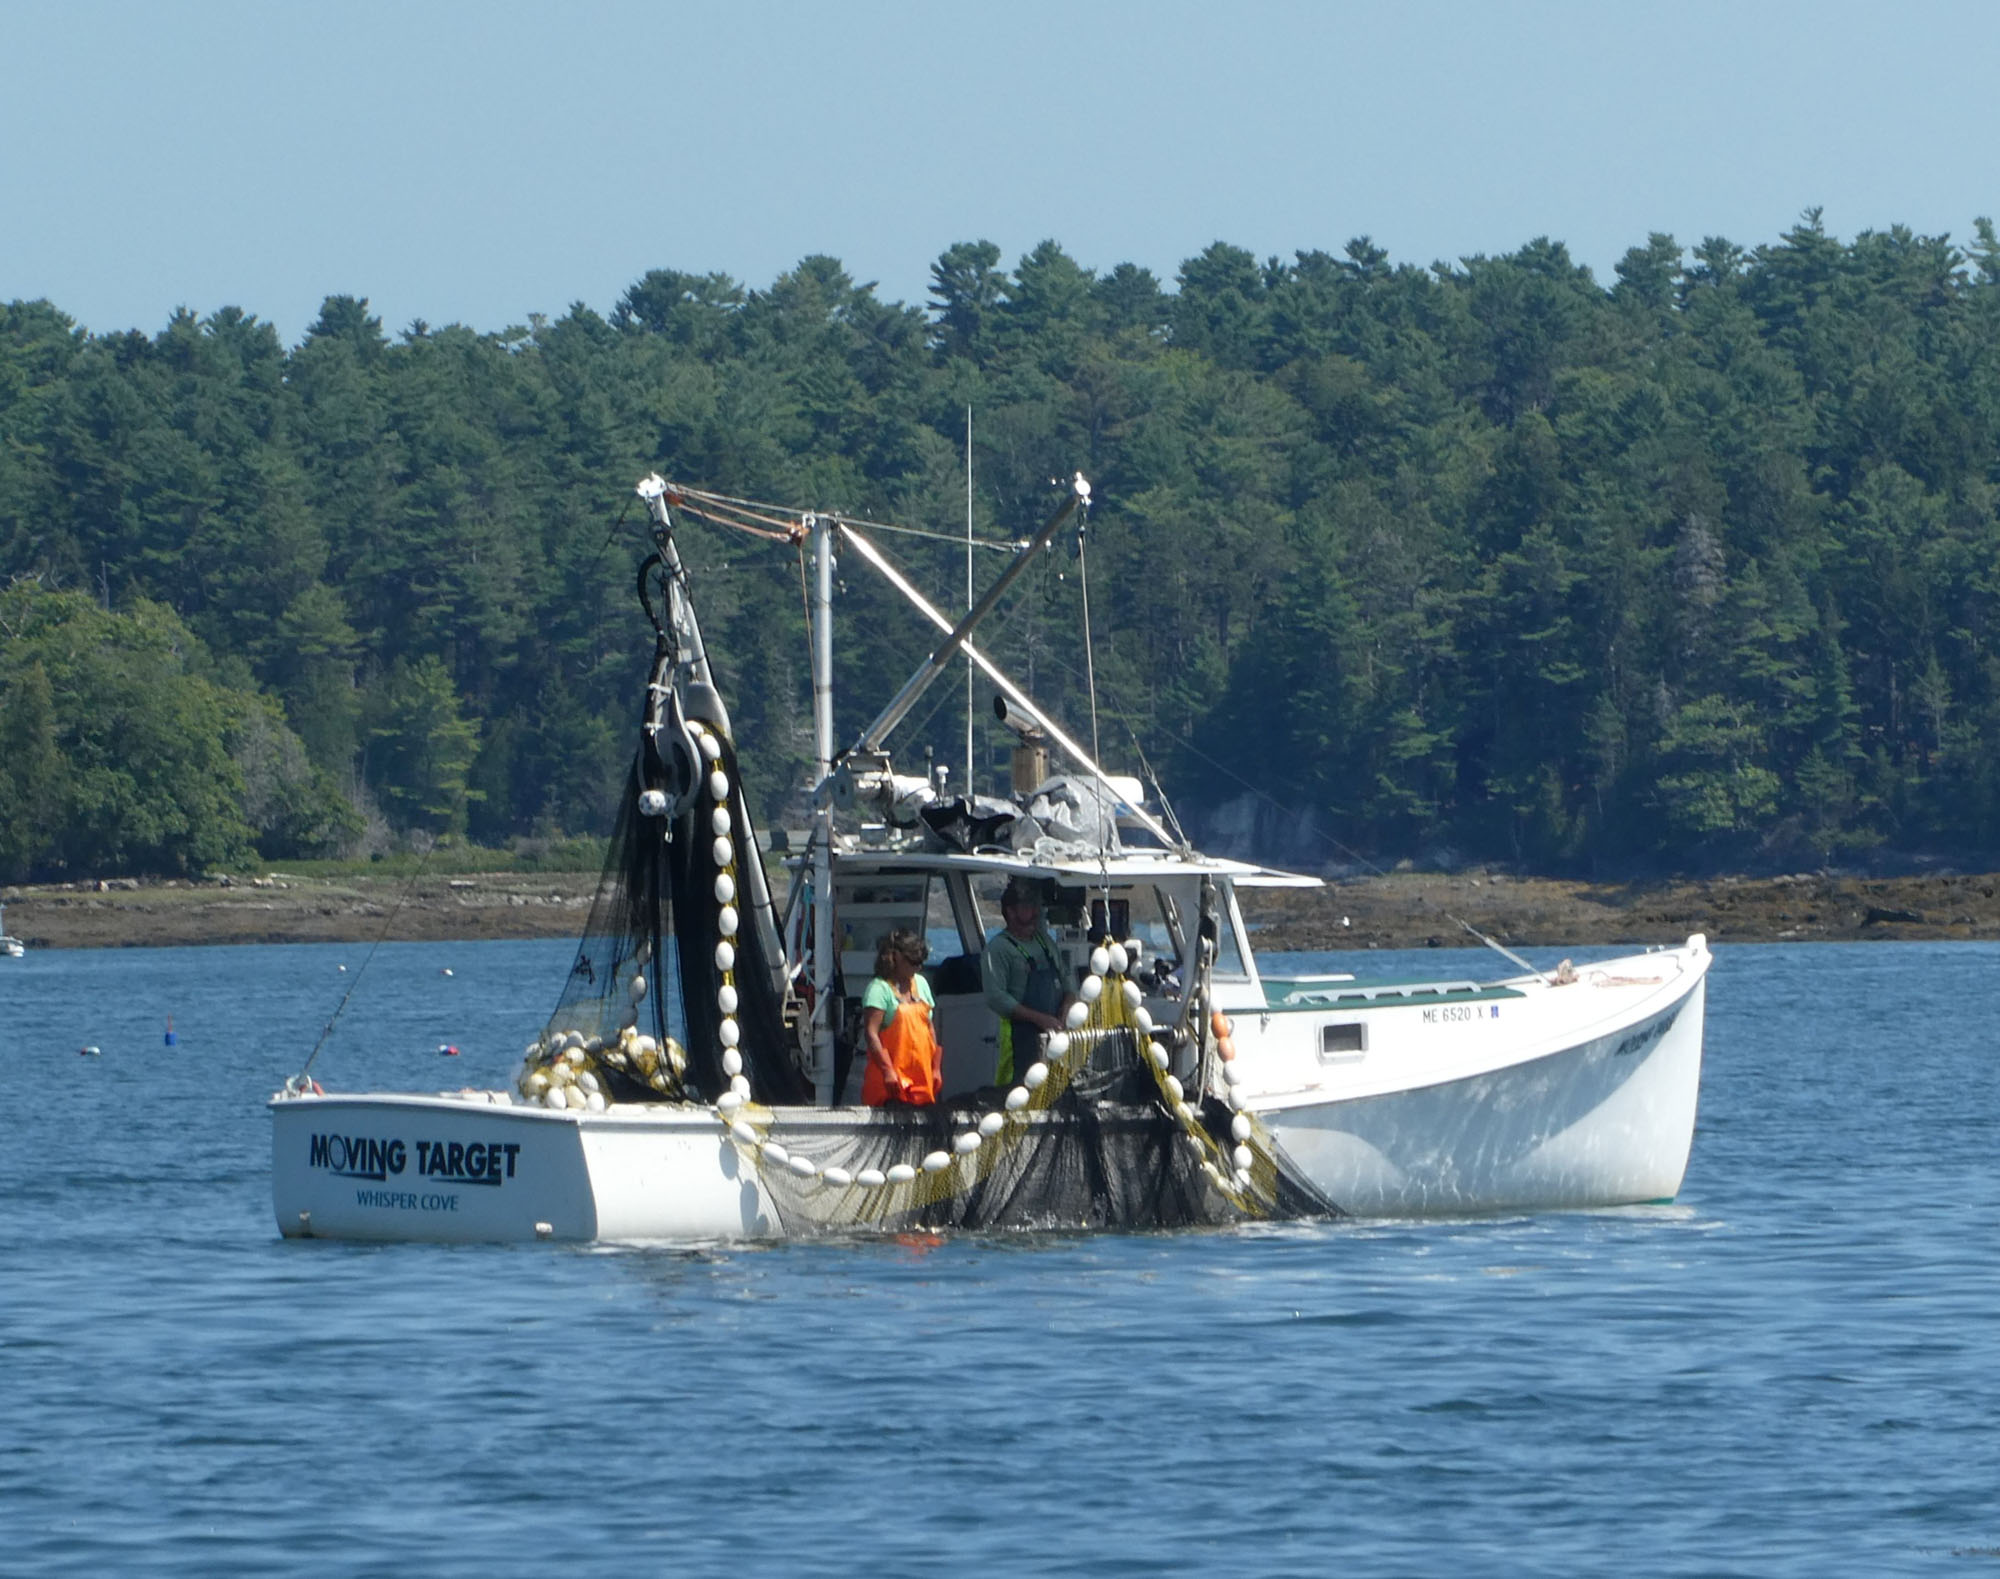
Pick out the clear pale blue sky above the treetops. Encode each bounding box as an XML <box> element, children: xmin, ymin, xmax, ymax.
<box><xmin>0</xmin><ymin>0</ymin><xmax>2000</xmax><ymax>340</ymax></box>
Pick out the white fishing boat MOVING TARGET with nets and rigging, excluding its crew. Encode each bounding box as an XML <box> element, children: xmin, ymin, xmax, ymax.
<box><xmin>270</xmin><ymin>476</ymin><xmax>1710</xmax><ymax>1241</ymax></box>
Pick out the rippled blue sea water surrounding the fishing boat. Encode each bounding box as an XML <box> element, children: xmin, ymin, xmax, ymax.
<box><xmin>0</xmin><ymin>943</ymin><xmax>2000</xmax><ymax>1575</ymax></box>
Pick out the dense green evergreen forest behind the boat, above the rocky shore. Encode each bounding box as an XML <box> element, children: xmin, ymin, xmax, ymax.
<box><xmin>0</xmin><ymin>212</ymin><xmax>2000</xmax><ymax>881</ymax></box>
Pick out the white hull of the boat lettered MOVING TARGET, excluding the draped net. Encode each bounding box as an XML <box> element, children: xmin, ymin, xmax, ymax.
<box><xmin>272</xmin><ymin>939</ymin><xmax>1708</xmax><ymax>1241</ymax></box>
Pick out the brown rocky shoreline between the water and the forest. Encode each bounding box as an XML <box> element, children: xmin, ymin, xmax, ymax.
<box><xmin>11</xmin><ymin>871</ymin><xmax>2000</xmax><ymax>949</ymax></box>
